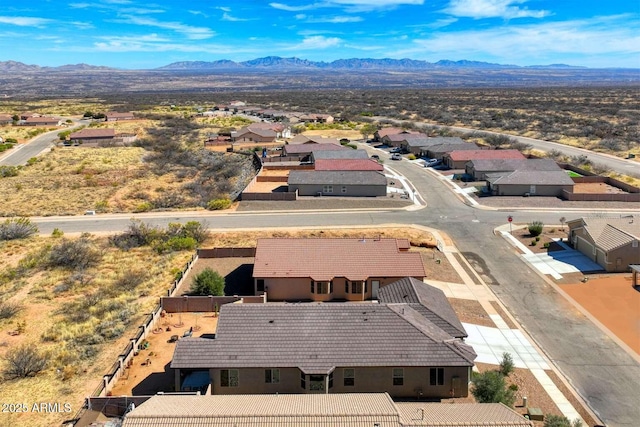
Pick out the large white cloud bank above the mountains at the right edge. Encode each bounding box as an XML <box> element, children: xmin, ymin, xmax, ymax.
<box><xmin>396</xmin><ymin>16</ymin><xmax>640</xmax><ymax>66</ymax></box>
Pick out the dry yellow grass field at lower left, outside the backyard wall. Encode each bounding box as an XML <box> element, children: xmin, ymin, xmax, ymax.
<box><xmin>0</xmin><ymin>237</ymin><xmax>192</xmax><ymax>426</ymax></box>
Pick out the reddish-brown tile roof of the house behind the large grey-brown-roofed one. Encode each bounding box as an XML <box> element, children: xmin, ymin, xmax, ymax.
<box><xmin>253</xmin><ymin>238</ymin><xmax>426</xmax><ymax>280</ymax></box>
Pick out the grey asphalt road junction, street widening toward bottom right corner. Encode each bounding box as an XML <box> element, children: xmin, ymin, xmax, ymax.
<box><xmin>34</xmin><ymin>155</ymin><xmax>640</xmax><ymax>426</ymax></box>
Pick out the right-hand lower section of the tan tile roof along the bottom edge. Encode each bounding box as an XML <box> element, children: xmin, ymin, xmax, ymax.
<box><xmin>396</xmin><ymin>402</ymin><xmax>533</xmax><ymax>427</ymax></box>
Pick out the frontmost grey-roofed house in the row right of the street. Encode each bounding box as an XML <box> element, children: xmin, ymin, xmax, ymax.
<box><xmin>486</xmin><ymin>169</ymin><xmax>575</xmax><ymax>197</ymax></box>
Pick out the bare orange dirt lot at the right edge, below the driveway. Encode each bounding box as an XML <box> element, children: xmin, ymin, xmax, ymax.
<box><xmin>559</xmin><ymin>274</ymin><xmax>640</xmax><ymax>354</ymax></box>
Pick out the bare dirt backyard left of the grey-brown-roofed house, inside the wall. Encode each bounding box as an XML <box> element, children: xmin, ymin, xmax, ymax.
<box><xmin>111</xmin><ymin>313</ymin><xmax>218</xmax><ymax>396</ymax></box>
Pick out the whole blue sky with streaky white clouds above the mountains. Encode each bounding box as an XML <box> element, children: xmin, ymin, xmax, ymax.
<box><xmin>0</xmin><ymin>0</ymin><xmax>640</xmax><ymax>69</ymax></box>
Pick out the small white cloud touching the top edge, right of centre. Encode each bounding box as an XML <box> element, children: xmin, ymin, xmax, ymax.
<box><xmin>444</xmin><ymin>0</ymin><xmax>550</xmax><ymax>19</ymax></box>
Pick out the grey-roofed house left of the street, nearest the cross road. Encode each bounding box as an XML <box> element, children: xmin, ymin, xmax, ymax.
<box><xmin>287</xmin><ymin>170</ymin><xmax>387</xmax><ymax>197</ymax></box>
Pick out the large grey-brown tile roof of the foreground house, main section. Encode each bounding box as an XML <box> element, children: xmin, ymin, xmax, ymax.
<box><xmin>171</xmin><ymin>303</ymin><xmax>476</xmax><ymax>375</ymax></box>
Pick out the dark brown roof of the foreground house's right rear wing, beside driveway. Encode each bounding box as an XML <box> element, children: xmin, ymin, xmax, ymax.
<box><xmin>378</xmin><ymin>277</ymin><xmax>468</xmax><ymax>338</ymax></box>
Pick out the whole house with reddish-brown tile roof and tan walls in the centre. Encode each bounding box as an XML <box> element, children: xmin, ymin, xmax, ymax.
<box><xmin>253</xmin><ymin>237</ymin><xmax>426</xmax><ymax>301</ymax></box>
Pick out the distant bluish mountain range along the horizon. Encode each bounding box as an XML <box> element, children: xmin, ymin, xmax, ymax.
<box><xmin>0</xmin><ymin>56</ymin><xmax>586</xmax><ymax>73</ymax></box>
